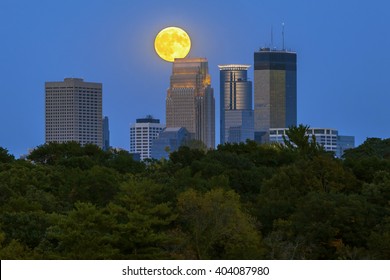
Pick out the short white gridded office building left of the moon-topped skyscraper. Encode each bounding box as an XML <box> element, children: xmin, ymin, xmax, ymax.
<box><xmin>130</xmin><ymin>115</ymin><xmax>165</xmax><ymax>160</ymax></box>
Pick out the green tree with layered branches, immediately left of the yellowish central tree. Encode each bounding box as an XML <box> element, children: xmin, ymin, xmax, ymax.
<box><xmin>107</xmin><ymin>176</ymin><xmax>176</xmax><ymax>259</ymax></box>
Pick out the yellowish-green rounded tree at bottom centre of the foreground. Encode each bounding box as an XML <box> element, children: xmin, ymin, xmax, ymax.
<box><xmin>178</xmin><ymin>189</ymin><xmax>264</xmax><ymax>259</ymax></box>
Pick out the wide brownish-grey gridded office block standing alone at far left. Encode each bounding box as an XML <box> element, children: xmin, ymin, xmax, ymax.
<box><xmin>45</xmin><ymin>78</ymin><xmax>103</xmax><ymax>148</ymax></box>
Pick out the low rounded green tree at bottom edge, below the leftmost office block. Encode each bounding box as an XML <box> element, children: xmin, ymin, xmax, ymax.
<box><xmin>40</xmin><ymin>202</ymin><xmax>119</xmax><ymax>260</ymax></box>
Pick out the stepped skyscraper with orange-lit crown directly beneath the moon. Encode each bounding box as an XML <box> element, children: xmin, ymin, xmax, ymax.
<box><xmin>166</xmin><ymin>58</ymin><xmax>215</xmax><ymax>148</ymax></box>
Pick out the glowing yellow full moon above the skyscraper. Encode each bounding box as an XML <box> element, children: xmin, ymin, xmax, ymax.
<box><xmin>154</xmin><ymin>27</ymin><xmax>191</xmax><ymax>62</ymax></box>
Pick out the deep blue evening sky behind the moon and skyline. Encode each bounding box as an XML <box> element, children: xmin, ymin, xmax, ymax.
<box><xmin>0</xmin><ymin>0</ymin><xmax>390</xmax><ymax>156</ymax></box>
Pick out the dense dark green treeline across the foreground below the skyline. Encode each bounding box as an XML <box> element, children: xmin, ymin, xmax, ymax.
<box><xmin>0</xmin><ymin>126</ymin><xmax>390</xmax><ymax>259</ymax></box>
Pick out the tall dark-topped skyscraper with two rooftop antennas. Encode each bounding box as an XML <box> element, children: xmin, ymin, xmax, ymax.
<box><xmin>254</xmin><ymin>48</ymin><xmax>297</xmax><ymax>142</ymax></box>
